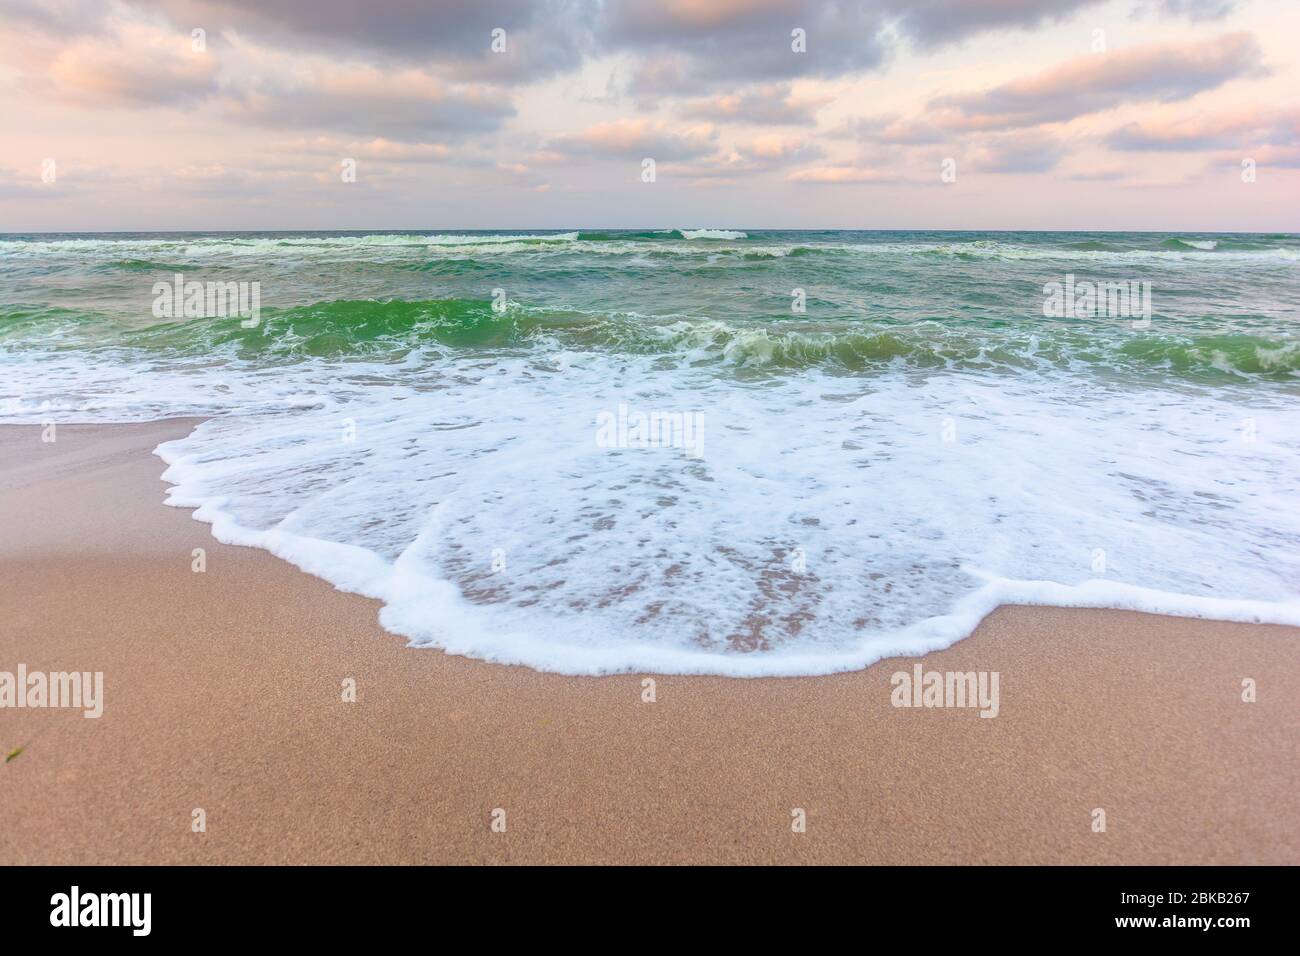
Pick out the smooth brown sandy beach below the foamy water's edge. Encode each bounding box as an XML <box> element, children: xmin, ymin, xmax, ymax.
<box><xmin>0</xmin><ymin>421</ymin><xmax>1300</xmax><ymax>864</ymax></box>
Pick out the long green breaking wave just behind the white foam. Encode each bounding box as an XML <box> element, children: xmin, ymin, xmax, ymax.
<box><xmin>22</xmin><ymin>298</ymin><xmax>1300</xmax><ymax>382</ymax></box>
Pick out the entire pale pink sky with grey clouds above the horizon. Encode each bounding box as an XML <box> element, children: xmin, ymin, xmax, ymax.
<box><xmin>0</xmin><ymin>0</ymin><xmax>1300</xmax><ymax>233</ymax></box>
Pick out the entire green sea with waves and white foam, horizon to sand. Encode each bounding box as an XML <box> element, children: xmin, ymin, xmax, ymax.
<box><xmin>0</xmin><ymin>230</ymin><xmax>1300</xmax><ymax>675</ymax></box>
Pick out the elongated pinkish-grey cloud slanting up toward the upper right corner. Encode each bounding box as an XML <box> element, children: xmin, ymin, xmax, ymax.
<box><xmin>930</xmin><ymin>33</ymin><xmax>1264</xmax><ymax>130</ymax></box>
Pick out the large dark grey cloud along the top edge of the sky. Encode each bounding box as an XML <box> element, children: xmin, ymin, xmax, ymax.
<box><xmin>126</xmin><ymin>0</ymin><xmax>1144</xmax><ymax>82</ymax></box>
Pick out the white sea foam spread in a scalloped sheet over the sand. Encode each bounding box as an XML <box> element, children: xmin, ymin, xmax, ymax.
<box><xmin>98</xmin><ymin>354</ymin><xmax>1300</xmax><ymax>676</ymax></box>
